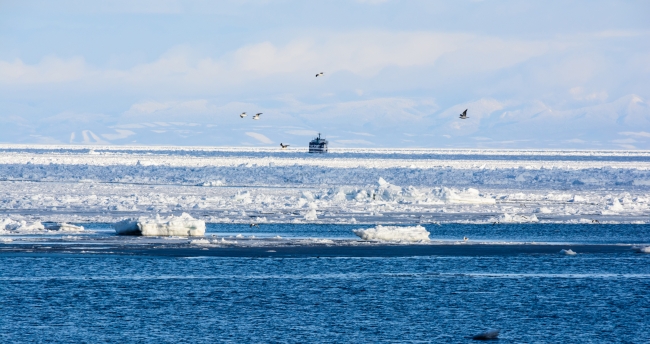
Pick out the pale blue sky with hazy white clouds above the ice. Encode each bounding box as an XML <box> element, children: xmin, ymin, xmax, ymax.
<box><xmin>0</xmin><ymin>0</ymin><xmax>650</xmax><ymax>149</ymax></box>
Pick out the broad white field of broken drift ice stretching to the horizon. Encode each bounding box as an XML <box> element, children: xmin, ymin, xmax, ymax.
<box><xmin>0</xmin><ymin>145</ymin><xmax>650</xmax><ymax>230</ymax></box>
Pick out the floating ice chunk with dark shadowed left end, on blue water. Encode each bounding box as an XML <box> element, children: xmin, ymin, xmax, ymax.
<box><xmin>113</xmin><ymin>213</ymin><xmax>205</xmax><ymax>236</ymax></box>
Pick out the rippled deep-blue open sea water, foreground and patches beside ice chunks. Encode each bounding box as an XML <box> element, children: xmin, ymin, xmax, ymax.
<box><xmin>0</xmin><ymin>225</ymin><xmax>650</xmax><ymax>343</ymax></box>
